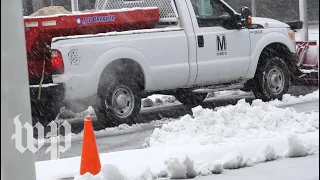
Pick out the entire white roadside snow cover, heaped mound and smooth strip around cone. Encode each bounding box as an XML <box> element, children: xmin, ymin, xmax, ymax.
<box><xmin>36</xmin><ymin>91</ymin><xmax>319</xmax><ymax>180</ymax></box>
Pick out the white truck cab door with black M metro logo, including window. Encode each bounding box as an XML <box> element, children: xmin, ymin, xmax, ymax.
<box><xmin>190</xmin><ymin>0</ymin><xmax>250</xmax><ymax>85</ymax></box>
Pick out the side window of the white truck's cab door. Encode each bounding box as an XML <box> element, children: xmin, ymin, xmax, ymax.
<box><xmin>191</xmin><ymin>0</ymin><xmax>231</xmax><ymax>27</ymax></box>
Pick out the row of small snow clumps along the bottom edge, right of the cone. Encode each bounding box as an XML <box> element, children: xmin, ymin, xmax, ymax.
<box><xmin>158</xmin><ymin>135</ymin><xmax>312</xmax><ymax>179</ymax></box>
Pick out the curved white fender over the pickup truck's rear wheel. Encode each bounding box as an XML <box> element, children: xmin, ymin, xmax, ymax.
<box><xmin>91</xmin><ymin>46</ymin><xmax>152</xmax><ymax>90</ymax></box>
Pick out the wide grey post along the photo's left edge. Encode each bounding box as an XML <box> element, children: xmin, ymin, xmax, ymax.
<box><xmin>1</xmin><ymin>0</ymin><xmax>36</xmax><ymax>180</ymax></box>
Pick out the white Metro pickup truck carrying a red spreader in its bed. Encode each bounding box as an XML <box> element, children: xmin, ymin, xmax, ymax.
<box><xmin>51</xmin><ymin>0</ymin><xmax>296</xmax><ymax>126</ymax></box>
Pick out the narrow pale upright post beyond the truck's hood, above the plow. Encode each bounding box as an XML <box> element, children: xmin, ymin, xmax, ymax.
<box><xmin>299</xmin><ymin>0</ymin><xmax>309</xmax><ymax>41</ymax></box>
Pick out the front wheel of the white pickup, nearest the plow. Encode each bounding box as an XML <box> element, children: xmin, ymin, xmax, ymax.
<box><xmin>252</xmin><ymin>57</ymin><xmax>290</xmax><ymax>101</ymax></box>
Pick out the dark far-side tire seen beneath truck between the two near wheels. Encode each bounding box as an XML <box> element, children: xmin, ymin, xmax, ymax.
<box><xmin>175</xmin><ymin>91</ymin><xmax>208</xmax><ymax>105</ymax></box>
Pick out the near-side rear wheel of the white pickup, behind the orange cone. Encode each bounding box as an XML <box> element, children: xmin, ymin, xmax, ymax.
<box><xmin>95</xmin><ymin>79</ymin><xmax>141</xmax><ymax>127</ymax></box>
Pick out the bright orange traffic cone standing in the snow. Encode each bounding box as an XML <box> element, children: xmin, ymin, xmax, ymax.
<box><xmin>80</xmin><ymin>116</ymin><xmax>101</xmax><ymax>175</ymax></box>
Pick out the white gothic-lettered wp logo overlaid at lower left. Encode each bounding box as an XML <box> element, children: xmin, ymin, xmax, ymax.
<box><xmin>11</xmin><ymin>114</ymin><xmax>71</xmax><ymax>160</ymax></box>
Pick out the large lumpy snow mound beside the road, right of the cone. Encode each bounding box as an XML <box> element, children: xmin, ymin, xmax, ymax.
<box><xmin>145</xmin><ymin>100</ymin><xmax>319</xmax><ymax>147</ymax></box>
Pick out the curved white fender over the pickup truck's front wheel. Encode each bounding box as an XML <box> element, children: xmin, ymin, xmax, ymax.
<box><xmin>246</xmin><ymin>32</ymin><xmax>296</xmax><ymax>79</ymax></box>
